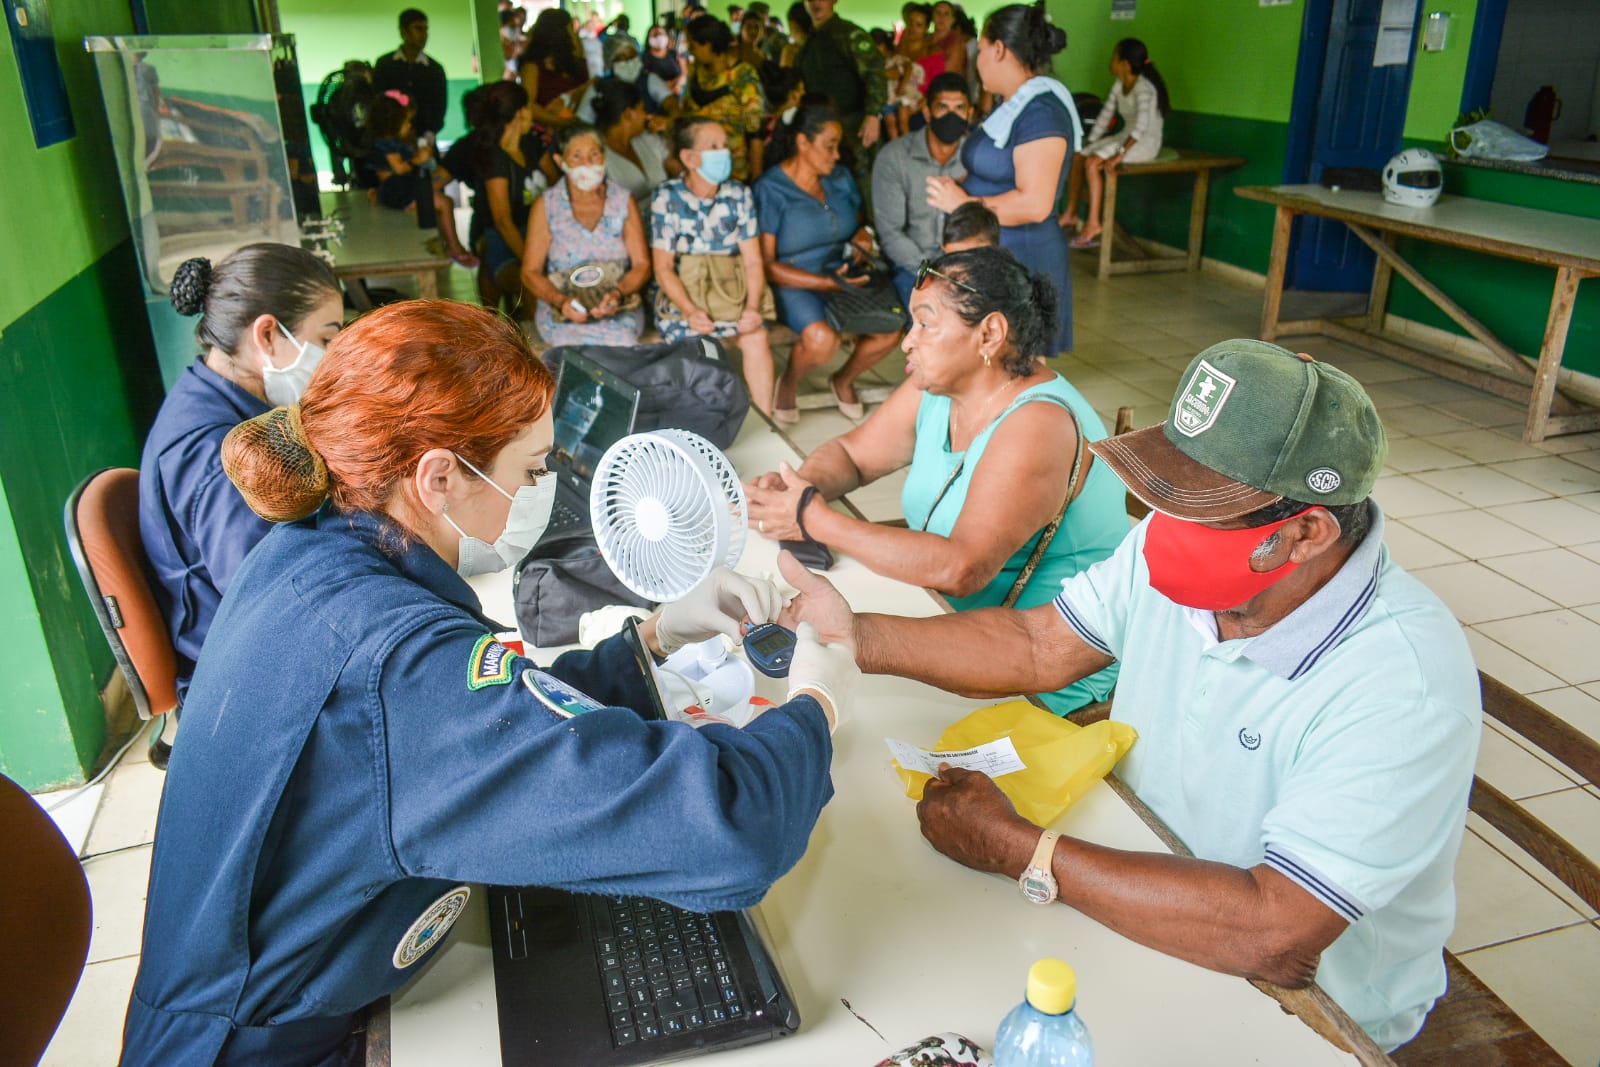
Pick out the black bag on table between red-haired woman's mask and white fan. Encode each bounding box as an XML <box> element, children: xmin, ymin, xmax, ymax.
<box><xmin>512</xmin><ymin>531</ymin><xmax>654</xmax><ymax>648</ymax></box>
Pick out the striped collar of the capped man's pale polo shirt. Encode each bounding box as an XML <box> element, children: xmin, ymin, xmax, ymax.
<box><xmin>1222</xmin><ymin>501</ymin><xmax>1384</xmax><ymax>681</ymax></box>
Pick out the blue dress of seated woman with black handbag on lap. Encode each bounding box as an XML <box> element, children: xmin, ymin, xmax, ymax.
<box><xmin>755</xmin><ymin>166</ymin><xmax>861</xmax><ymax>333</ymax></box>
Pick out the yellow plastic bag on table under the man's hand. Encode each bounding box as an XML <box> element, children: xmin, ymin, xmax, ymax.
<box><xmin>894</xmin><ymin>701</ymin><xmax>1139</xmax><ymax>825</ymax></box>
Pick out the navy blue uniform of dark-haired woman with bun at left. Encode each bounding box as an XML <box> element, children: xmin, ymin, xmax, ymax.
<box><xmin>139</xmin><ymin>360</ymin><xmax>272</xmax><ymax>697</ymax></box>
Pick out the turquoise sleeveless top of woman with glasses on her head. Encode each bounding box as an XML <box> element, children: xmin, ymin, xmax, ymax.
<box><xmin>901</xmin><ymin>374</ymin><xmax>1128</xmax><ymax>715</ymax></box>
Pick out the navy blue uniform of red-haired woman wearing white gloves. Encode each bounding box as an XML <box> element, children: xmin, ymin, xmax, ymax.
<box><xmin>123</xmin><ymin>509</ymin><xmax>832</xmax><ymax>1067</ymax></box>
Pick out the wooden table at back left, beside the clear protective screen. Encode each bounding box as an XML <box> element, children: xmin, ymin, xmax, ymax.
<box><xmin>322</xmin><ymin>189</ymin><xmax>450</xmax><ymax>310</ymax></box>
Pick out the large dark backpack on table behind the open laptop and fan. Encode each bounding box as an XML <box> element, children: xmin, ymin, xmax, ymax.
<box><xmin>544</xmin><ymin>338</ymin><xmax>750</xmax><ymax>448</ymax></box>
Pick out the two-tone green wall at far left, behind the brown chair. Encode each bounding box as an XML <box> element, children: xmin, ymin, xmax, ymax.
<box><xmin>0</xmin><ymin>0</ymin><xmax>160</xmax><ymax>789</ymax></box>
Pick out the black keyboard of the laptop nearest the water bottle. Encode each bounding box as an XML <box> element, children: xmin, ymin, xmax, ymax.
<box><xmin>587</xmin><ymin>896</ymin><xmax>746</xmax><ymax>1046</ymax></box>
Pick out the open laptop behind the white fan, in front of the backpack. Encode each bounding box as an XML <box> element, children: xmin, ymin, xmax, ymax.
<box><xmin>541</xmin><ymin>350</ymin><xmax>638</xmax><ymax>541</ymax></box>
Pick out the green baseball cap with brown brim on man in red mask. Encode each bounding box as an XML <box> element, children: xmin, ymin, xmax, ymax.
<box><xmin>1090</xmin><ymin>339</ymin><xmax>1389</xmax><ymax>522</ymax></box>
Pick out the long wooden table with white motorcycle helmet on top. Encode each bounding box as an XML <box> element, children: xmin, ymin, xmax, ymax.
<box><xmin>1234</xmin><ymin>186</ymin><xmax>1600</xmax><ymax>443</ymax></box>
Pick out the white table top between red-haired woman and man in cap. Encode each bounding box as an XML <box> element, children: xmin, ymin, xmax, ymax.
<box><xmin>390</xmin><ymin>414</ymin><xmax>1354</xmax><ymax>1067</ymax></box>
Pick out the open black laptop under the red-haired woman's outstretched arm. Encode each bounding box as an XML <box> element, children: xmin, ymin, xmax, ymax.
<box><xmin>490</xmin><ymin>619</ymin><xmax>800</xmax><ymax>1067</ymax></box>
